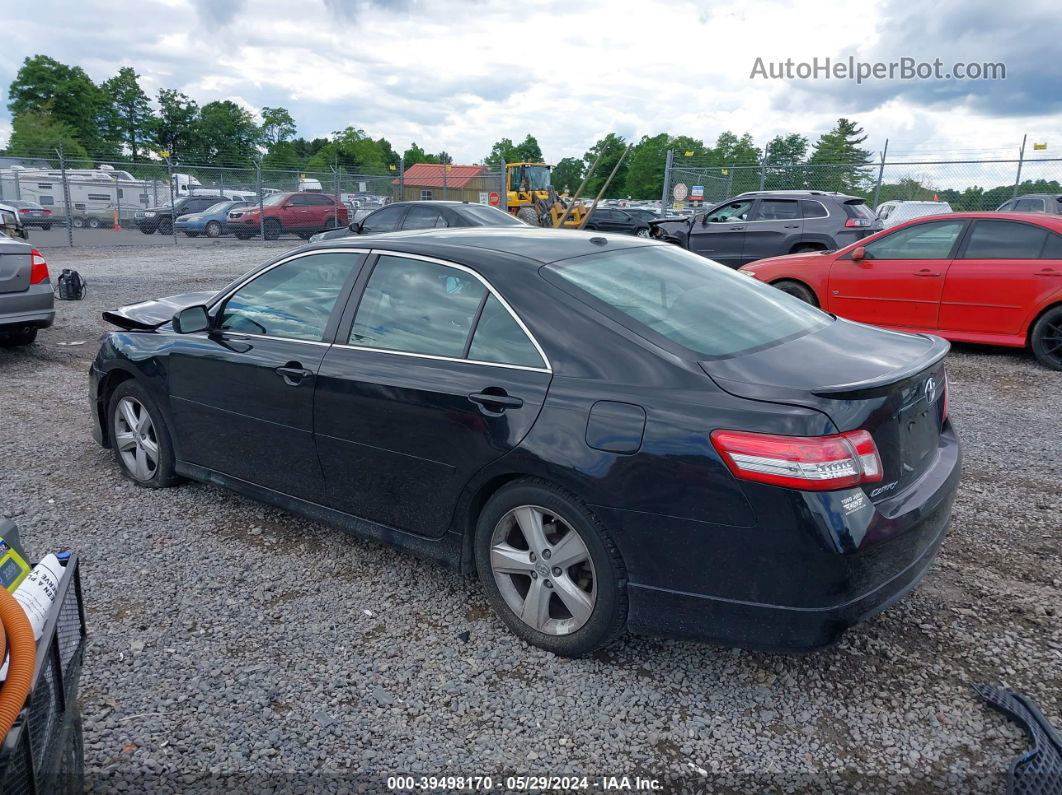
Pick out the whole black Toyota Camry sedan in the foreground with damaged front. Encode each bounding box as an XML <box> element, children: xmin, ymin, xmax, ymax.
<box><xmin>90</xmin><ymin>228</ymin><xmax>960</xmax><ymax>655</ymax></box>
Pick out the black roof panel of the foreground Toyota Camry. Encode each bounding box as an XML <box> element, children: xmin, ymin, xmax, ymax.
<box><xmin>303</xmin><ymin>226</ymin><xmax>667</xmax><ymax>265</ymax></box>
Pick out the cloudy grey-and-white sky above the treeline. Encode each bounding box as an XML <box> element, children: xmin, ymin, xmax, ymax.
<box><xmin>0</xmin><ymin>0</ymin><xmax>1062</xmax><ymax>162</ymax></box>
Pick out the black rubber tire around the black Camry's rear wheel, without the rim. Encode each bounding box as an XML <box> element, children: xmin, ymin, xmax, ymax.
<box><xmin>475</xmin><ymin>479</ymin><xmax>628</xmax><ymax>657</ymax></box>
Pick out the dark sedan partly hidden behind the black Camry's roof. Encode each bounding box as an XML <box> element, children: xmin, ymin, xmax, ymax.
<box><xmin>310</xmin><ymin>201</ymin><xmax>527</xmax><ymax>243</ymax></box>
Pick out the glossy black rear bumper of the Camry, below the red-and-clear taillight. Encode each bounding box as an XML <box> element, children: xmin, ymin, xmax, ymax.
<box><xmin>602</xmin><ymin>426</ymin><xmax>961</xmax><ymax>652</ymax></box>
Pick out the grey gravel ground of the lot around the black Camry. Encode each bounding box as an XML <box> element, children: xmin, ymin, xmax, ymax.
<box><xmin>0</xmin><ymin>242</ymin><xmax>1062</xmax><ymax>793</ymax></box>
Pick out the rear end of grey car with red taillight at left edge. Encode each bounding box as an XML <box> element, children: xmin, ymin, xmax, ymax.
<box><xmin>0</xmin><ymin>235</ymin><xmax>55</xmax><ymax>346</ymax></box>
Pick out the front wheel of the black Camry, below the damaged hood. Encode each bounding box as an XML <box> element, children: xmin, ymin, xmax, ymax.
<box><xmin>107</xmin><ymin>381</ymin><xmax>181</xmax><ymax>488</ymax></box>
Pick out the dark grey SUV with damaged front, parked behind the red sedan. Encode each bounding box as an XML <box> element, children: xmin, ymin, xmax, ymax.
<box><xmin>649</xmin><ymin>190</ymin><xmax>883</xmax><ymax>267</ymax></box>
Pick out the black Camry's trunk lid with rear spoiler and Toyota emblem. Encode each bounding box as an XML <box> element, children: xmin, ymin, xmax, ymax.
<box><xmin>700</xmin><ymin>318</ymin><xmax>950</xmax><ymax>500</ymax></box>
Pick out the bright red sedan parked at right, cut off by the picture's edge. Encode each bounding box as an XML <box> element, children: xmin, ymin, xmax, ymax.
<box><xmin>740</xmin><ymin>212</ymin><xmax>1062</xmax><ymax>369</ymax></box>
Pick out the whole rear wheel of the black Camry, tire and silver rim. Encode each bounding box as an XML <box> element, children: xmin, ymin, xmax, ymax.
<box><xmin>475</xmin><ymin>480</ymin><xmax>627</xmax><ymax>657</ymax></box>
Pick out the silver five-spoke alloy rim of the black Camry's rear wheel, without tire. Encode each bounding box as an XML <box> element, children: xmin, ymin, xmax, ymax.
<box><xmin>491</xmin><ymin>505</ymin><xmax>597</xmax><ymax>635</ymax></box>
